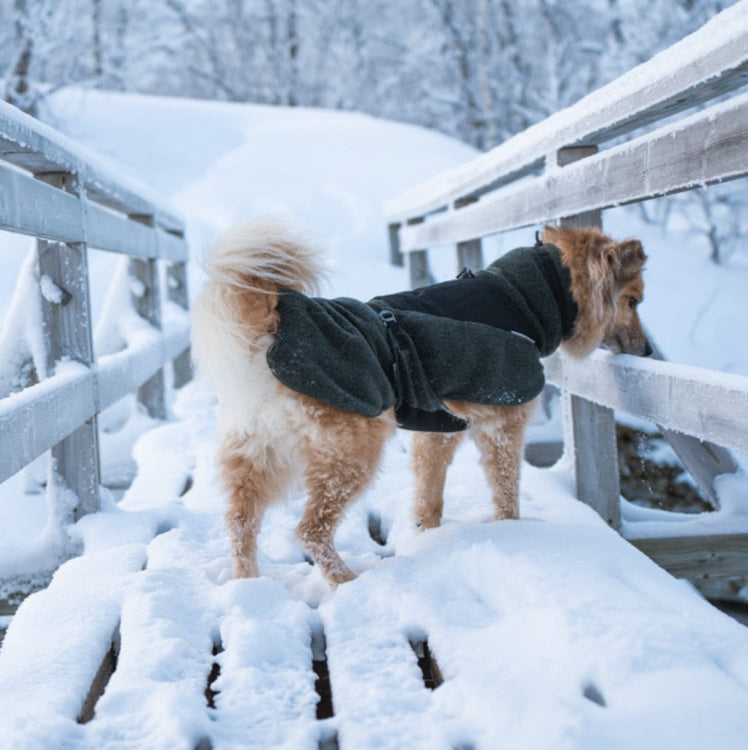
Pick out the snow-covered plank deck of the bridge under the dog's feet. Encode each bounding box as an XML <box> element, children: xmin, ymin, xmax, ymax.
<box><xmin>0</xmin><ymin>383</ymin><xmax>748</xmax><ymax>750</ymax></box>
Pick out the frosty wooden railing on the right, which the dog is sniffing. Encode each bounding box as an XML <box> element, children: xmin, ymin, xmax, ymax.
<box><xmin>385</xmin><ymin>2</ymin><xmax>748</xmax><ymax>576</ymax></box>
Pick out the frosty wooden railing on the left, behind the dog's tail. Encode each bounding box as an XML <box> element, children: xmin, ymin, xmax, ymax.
<box><xmin>0</xmin><ymin>103</ymin><xmax>190</xmax><ymax>517</ymax></box>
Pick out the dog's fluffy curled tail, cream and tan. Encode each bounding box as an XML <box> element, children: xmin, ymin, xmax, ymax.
<box><xmin>192</xmin><ymin>219</ymin><xmax>325</xmax><ymax>381</ymax></box>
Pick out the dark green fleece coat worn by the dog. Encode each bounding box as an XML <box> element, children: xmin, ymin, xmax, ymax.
<box><xmin>267</xmin><ymin>245</ymin><xmax>577</xmax><ymax>431</ymax></box>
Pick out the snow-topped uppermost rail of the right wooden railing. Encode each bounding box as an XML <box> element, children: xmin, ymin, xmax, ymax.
<box><xmin>384</xmin><ymin>1</ymin><xmax>748</xmax><ymax>223</ymax></box>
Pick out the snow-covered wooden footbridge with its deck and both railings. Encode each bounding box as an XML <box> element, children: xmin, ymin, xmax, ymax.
<box><xmin>0</xmin><ymin>3</ymin><xmax>748</xmax><ymax>750</ymax></box>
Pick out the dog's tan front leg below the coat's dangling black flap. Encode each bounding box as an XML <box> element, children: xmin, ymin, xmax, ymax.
<box><xmin>412</xmin><ymin>432</ymin><xmax>464</xmax><ymax>529</ymax></box>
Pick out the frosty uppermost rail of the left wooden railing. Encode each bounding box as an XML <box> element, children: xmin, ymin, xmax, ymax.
<box><xmin>0</xmin><ymin>102</ymin><xmax>184</xmax><ymax>234</ymax></box>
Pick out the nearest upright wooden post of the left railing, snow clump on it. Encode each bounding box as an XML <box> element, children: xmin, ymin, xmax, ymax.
<box><xmin>37</xmin><ymin>173</ymin><xmax>101</xmax><ymax>520</ymax></box>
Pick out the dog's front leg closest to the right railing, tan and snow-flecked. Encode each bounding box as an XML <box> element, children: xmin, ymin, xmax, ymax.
<box><xmin>471</xmin><ymin>402</ymin><xmax>534</xmax><ymax>521</ymax></box>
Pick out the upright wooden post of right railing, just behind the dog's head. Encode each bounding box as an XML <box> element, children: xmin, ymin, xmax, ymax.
<box><xmin>556</xmin><ymin>146</ymin><xmax>621</xmax><ymax>529</ymax></box>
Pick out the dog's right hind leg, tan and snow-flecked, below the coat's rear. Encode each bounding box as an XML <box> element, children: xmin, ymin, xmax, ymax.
<box><xmin>296</xmin><ymin>412</ymin><xmax>394</xmax><ymax>586</ymax></box>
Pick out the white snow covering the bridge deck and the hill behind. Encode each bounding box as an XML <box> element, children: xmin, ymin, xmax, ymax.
<box><xmin>0</xmin><ymin>91</ymin><xmax>748</xmax><ymax>750</ymax></box>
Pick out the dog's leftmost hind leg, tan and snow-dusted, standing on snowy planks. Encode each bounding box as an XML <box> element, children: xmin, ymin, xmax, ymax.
<box><xmin>219</xmin><ymin>446</ymin><xmax>286</xmax><ymax>578</ymax></box>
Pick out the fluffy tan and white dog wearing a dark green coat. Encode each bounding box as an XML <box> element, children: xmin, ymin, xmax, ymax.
<box><xmin>192</xmin><ymin>221</ymin><xmax>651</xmax><ymax>586</ymax></box>
